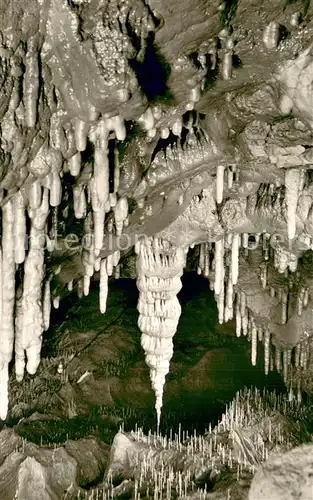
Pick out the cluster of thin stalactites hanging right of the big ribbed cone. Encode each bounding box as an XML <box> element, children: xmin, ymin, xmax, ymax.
<box><xmin>198</xmin><ymin>225</ymin><xmax>312</xmax><ymax>392</ymax></box>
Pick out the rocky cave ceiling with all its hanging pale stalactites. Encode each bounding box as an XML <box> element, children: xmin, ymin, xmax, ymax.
<box><xmin>0</xmin><ymin>0</ymin><xmax>313</xmax><ymax>420</ymax></box>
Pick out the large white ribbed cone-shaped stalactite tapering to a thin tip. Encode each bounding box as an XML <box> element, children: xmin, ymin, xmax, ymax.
<box><xmin>136</xmin><ymin>238</ymin><xmax>186</xmax><ymax>425</ymax></box>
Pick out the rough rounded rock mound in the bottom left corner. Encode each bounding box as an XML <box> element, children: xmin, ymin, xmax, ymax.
<box><xmin>0</xmin><ymin>429</ymin><xmax>108</xmax><ymax>500</ymax></box>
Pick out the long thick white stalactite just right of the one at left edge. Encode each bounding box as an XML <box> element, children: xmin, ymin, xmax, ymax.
<box><xmin>15</xmin><ymin>188</ymin><xmax>49</xmax><ymax>380</ymax></box>
